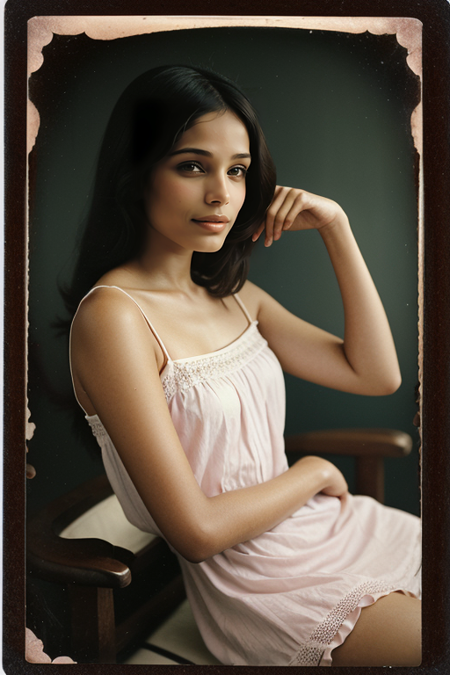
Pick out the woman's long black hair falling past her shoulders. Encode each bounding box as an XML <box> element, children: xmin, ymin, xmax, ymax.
<box><xmin>62</xmin><ymin>66</ymin><xmax>276</xmax><ymax>316</ymax></box>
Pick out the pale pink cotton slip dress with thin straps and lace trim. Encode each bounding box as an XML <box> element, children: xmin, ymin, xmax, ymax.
<box><xmin>70</xmin><ymin>286</ymin><xmax>421</xmax><ymax>666</ymax></box>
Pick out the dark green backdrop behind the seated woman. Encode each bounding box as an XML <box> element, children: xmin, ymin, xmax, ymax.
<box><xmin>28</xmin><ymin>28</ymin><xmax>419</xmax><ymax>513</ymax></box>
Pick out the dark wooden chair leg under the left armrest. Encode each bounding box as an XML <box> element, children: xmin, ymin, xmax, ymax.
<box><xmin>69</xmin><ymin>584</ymin><xmax>116</xmax><ymax>663</ymax></box>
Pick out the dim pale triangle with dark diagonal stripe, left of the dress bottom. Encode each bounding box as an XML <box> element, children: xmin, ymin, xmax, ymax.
<box><xmin>124</xmin><ymin>600</ymin><xmax>220</xmax><ymax>665</ymax></box>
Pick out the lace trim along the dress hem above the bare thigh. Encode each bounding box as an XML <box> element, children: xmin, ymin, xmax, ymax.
<box><xmin>289</xmin><ymin>580</ymin><xmax>398</xmax><ymax>666</ymax></box>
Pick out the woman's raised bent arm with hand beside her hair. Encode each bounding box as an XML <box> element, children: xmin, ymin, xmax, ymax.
<box><xmin>248</xmin><ymin>187</ymin><xmax>401</xmax><ymax>396</ymax></box>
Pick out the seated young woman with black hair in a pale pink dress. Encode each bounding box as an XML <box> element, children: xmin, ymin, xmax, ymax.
<box><xmin>67</xmin><ymin>66</ymin><xmax>420</xmax><ymax>666</ymax></box>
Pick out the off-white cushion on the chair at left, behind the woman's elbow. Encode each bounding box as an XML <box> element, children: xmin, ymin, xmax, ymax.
<box><xmin>60</xmin><ymin>495</ymin><xmax>155</xmax><ymax>553</ymax></box>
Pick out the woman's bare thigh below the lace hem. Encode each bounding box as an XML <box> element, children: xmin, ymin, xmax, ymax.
<box><xmin>332</xmin><ymin>593</ymin><xmax>422</xmax><ymax>666</ymax></box>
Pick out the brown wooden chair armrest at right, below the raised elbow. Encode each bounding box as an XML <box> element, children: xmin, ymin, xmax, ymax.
<box><xmin>285</xmin><ymin>429</ymin><xmax>412</xmax><ymax>457</ymax></box>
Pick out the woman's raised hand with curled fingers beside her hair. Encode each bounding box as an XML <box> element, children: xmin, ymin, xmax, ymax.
<box><xmin>252</xmin><ymin>185</ymin><xmax>346</xmax><ymax>246</ymax></box>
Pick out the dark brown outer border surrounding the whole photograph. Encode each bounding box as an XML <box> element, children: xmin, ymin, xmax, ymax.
<box><xmin>3</xmin><ymin>0</ymin><xmax>450</xmax><ymax>675</ymax></box>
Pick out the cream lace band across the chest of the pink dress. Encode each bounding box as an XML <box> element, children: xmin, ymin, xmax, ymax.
<box><xmin>161</xmin><ymin>323</ymin><xmax>267</xmax><ymax>400</ymax></box>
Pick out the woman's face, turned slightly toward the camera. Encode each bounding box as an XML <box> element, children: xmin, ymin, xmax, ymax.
<box><xmin>144</xmin><ymin>110</ymin><xmax>250</xmax><ymax>252</ymax></box>
